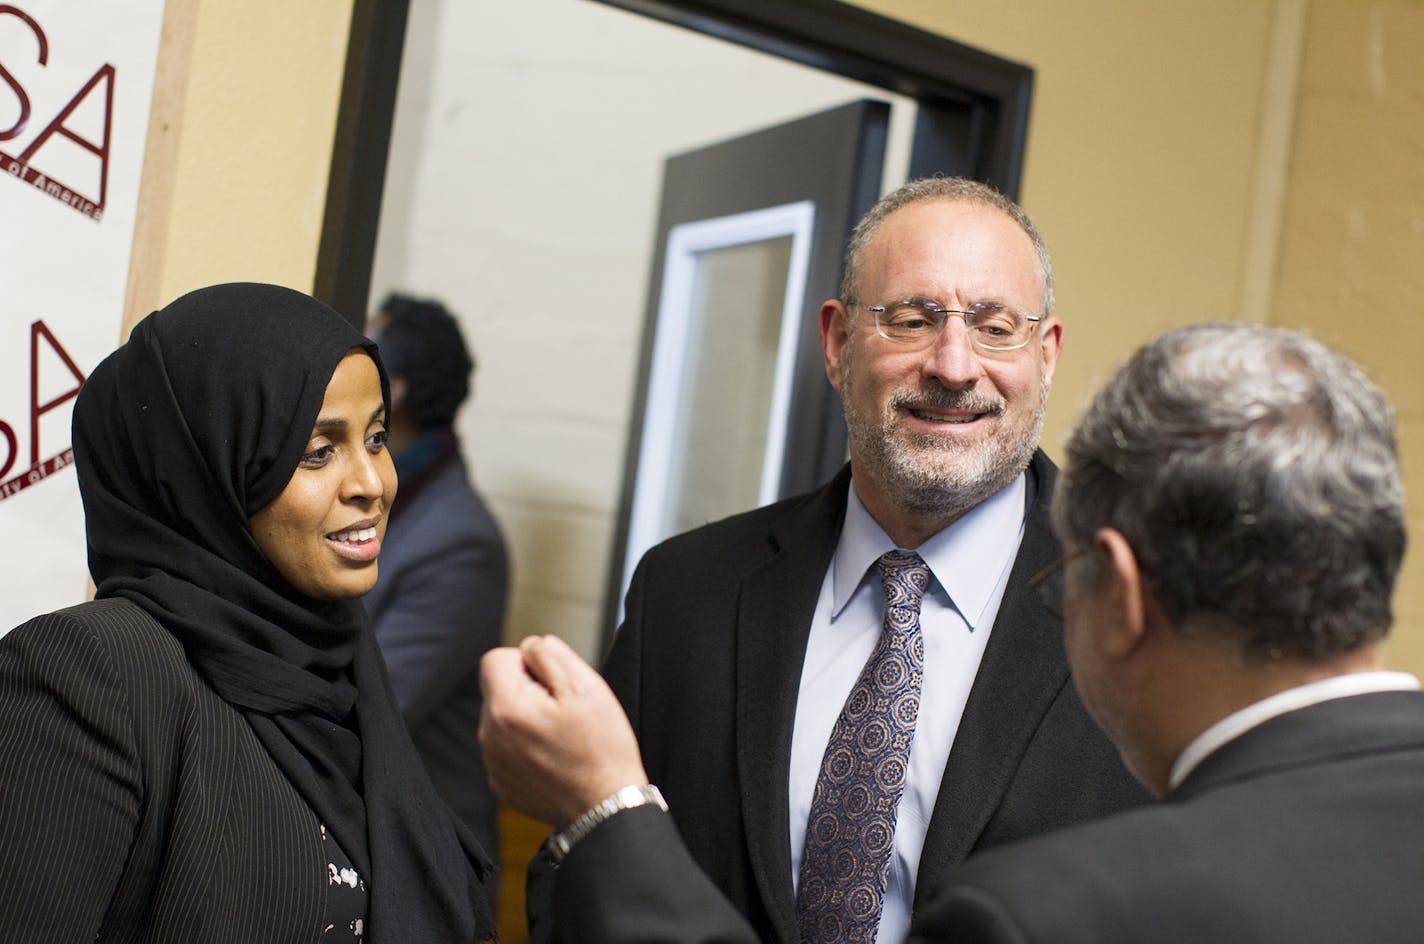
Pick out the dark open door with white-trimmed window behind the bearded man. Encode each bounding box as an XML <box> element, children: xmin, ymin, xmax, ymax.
<box><xmin>601</xmin><ymin>98</ymin><xmax>890</xmax><ymax>635</ymax></box>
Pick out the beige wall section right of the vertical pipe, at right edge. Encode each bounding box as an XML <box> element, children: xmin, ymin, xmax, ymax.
<box><xmin>1272</xmin><ymin>0</ymin><xmax>1424</xmax><ymax>675</ymax></box>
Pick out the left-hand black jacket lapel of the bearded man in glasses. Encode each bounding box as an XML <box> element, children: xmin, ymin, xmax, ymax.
<box><xmin>736</xmin><ymin>468</ymin><xmax>850</xmax><ymax>941</ymax></box>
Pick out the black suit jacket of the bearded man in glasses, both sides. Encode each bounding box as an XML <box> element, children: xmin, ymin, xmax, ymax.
<box><xmin>566</xmin><ymin>453</ymin><xmax>1146</xmax><ymax>943</ymax></box>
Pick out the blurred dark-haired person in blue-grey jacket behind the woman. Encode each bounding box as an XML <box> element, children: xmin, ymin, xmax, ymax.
<box><xmin>365</xmin><ymin>293</ymin><xmax>508</xmax><ymax>894</ymax></box>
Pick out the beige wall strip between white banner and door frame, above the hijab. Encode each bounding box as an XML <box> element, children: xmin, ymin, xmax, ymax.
<box><xmin>122</xmin><ymin>0</ymin><xmax>352</xmax><ymax>333</ymax></box>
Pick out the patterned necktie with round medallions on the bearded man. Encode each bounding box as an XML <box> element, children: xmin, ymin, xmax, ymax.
<box><xmin>796</xmin><ymin>551</ymin><xmax>930</xmax><ymax>944</ymax></box>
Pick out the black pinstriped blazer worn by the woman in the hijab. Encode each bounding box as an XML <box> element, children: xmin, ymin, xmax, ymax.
<box><xmin>0</xmin><ymin>599</ymin><xmax>328</xmax><ymax>944</ymax></box>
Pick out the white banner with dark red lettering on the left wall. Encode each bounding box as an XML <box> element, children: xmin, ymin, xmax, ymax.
<box><xmin>0</xmin><ymin>0</ymin><xmax>164</xmax><ymax>634</ymax></box>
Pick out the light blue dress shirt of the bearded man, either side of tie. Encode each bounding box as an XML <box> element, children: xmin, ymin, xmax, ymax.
<box><xmin>787</xmin><ymin>474</ymin><xmax>1027</xmax><ymax>943</ymax></box>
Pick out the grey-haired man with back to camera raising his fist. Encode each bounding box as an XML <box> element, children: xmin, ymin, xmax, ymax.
<box><xmin>481</xmin><ymin>325</ymin><xmax>1424</xmax><ymax>944</ymax></box>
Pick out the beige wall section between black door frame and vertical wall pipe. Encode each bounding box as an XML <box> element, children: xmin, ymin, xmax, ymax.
<box><xmin>837</xmin><ymin>0</ymin><xmax>1272</xmax><ymax>454</ymax></box>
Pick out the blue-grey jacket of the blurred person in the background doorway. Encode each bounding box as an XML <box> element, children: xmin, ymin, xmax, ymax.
<box><xmin>366</xmin><ymin>456</ymin><xmax>508</xmax><ymax>850</ymax></box>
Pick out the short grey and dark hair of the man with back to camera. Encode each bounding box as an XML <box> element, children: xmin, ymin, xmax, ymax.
<box><xmin>1054</xmin><ymin>323</ymin><xmax>1405</xmax><ymax>661</ymax></box>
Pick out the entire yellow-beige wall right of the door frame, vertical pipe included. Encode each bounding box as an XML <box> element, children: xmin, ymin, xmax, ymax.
<box><xmin>857</xmin><ymin>0</ymin><xmax>1424</xmax><ymax>675</ymax></box>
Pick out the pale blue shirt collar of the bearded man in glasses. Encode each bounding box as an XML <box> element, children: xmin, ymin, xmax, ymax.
<box><xmin>832</xmin><ymin>473</ymin><xmax>1027</xmax><ymax>629</ymax></box>
